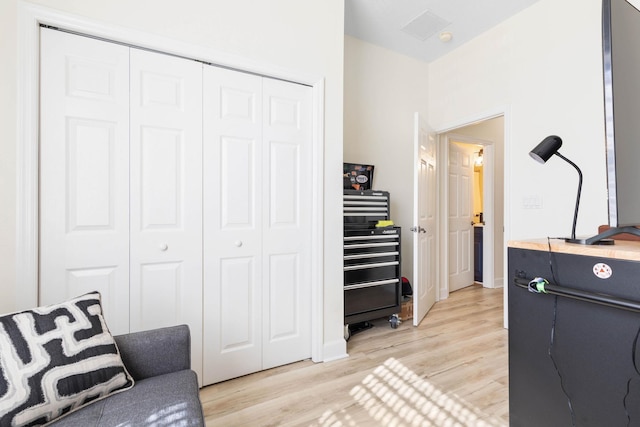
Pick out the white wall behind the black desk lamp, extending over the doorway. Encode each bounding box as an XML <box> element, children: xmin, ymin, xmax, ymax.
<box><xmin>428</xmin><ymin>0</ymin><xmax>607</xmax><ymax>239</ymax></box>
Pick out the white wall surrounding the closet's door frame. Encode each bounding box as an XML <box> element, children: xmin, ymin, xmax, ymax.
<box><xmin>0</xmin><ymin>0</ymin><xmax>346</xmax><ymax>358</ymax></box>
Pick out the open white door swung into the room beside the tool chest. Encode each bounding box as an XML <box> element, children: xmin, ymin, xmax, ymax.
<box><xmin>413</xmin><ymin>113</ymin><xmax>437</xmax><ymax>326</ymax></box>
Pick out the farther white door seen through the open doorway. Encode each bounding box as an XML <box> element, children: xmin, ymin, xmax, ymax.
<box><xmin>448</xmin><ymin>143</ymin><xmax>473</xmax><ymax>292</ymax></box>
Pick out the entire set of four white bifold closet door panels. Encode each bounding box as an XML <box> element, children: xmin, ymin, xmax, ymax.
<box><xmin>39</xmin><ymin>29</ymin><xmax>313</xmax><ymax>384</ymax></box>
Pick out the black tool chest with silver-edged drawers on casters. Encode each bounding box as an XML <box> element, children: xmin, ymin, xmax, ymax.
<box><xmin>344</xmin><ymin>190</ymin><xmax>402</xmax><ymax>328</ymax></box>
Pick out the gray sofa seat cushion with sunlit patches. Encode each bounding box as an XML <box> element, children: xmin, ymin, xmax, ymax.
<box><xmin>50</xmin><ymin>369</ymin><xmax>204</xmax><ymax>427</ymax></box>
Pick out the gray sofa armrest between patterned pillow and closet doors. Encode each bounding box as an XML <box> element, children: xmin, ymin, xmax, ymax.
<box><xmin>114</xmin><ymin>325</ymin><xmax>191</xmax><ymax>380</ymax></box>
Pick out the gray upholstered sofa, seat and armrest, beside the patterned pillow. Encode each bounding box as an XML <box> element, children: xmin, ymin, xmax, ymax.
<box><xmin>50</xmin><ymin>325</ymin><xmax>204</xmax><ymax>427</ymax></box>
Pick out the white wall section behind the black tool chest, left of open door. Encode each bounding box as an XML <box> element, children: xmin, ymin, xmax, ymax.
<box><xmin>344</xmin><ymin>36</ymin><xmax>428</xmax><ymax>280</ymax></box>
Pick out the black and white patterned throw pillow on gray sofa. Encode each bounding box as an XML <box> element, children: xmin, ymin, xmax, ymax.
<box><xmin>0</xmin><ymin>292</ymin><xmax>133</xmax><ymax>426</ymax></box>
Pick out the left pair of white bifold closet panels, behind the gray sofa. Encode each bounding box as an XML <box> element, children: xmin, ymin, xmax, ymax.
<box><xmin>40</xmin><ymin>29</ymin><xmax>202</xmax><ymax>372</ymax></box>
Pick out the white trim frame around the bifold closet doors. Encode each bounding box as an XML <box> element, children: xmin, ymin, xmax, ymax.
<box><xmin>15</xmin><ymin>1</ymin><xmax>325</xmax><ymax>362</ymax></box>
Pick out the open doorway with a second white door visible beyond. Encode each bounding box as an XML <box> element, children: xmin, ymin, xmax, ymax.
<box><xmin>438</xmin><ymin>115</ymin><xmax>504</xmax><ymax>298</ymax></box>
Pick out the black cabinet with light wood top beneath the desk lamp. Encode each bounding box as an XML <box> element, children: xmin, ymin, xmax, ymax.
<box><xmin>508</xmin><ymin>242</ymin><xmax>640</xmax><ymax>427</ymax></box>
